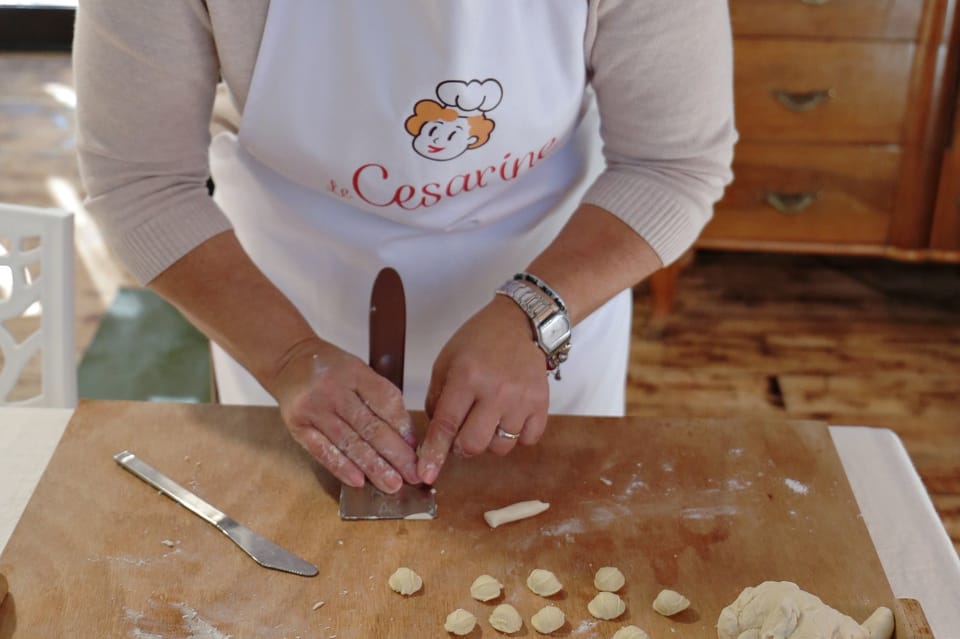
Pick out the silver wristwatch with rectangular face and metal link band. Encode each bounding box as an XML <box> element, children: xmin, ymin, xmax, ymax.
<box><xmin>497</xmin><ymin>279</ymin><xmax>572</xmax><ymax>379</ymax></box>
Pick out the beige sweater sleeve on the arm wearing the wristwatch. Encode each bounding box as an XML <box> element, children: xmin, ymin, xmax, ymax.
<box><xmin>584</xmin><ymin>0</ymin><xmax>737</xmax><ymax>265</ymax></box>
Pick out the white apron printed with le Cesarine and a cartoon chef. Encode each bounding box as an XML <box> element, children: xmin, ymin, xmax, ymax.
<box><xmin>210</xmin><ymin>0</ymin><xmax>631</xmax><ymax>415</ymax></box>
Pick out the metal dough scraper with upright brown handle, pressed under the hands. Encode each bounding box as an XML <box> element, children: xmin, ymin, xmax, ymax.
<box><xmin>340</xmin><ymin>268</ymin><xmax>437</xmax><ymax>519</ymax></box>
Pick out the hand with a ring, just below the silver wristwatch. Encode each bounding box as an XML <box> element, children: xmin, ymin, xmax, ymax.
<box><xmin>417</xmin><ymin>296</ymin><xmax>549</xmax><ymax>484</ymax></box>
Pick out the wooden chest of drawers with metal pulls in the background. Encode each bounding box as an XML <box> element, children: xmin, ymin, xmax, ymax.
<box><xmin>699</xmin><ymin>0</ymin><xmax>960</xmax><ymax>261</ymax></box>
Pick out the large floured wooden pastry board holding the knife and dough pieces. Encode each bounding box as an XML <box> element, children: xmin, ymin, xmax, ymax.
<box><xmin>0</xmin><ymin>401</ymin><xmax>928</xmax><ymax>639</ymax></box>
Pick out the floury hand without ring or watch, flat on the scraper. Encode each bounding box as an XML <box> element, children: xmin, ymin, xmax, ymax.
<box><xmin>267</xmin><ymin>339</ymin><xmax>420</xmax><ymax>493</ymax></box>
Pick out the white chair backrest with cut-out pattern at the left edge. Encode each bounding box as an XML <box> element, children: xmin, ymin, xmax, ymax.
<box><xmin>0</xmin><ymin>203</ymin><xmax>77</xmax><ymax>408</ymax></box>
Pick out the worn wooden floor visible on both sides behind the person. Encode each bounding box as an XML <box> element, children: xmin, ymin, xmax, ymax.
<box><xmin>0</xmin><ymin>54</ymin><xmax>960</xmax><ymax>549</ymax></box>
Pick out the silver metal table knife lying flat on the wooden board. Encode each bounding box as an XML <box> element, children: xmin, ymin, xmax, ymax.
<box><xmin>113</xmin><ymin>450</ymin><xmax>319</xmax><ymax>577</ymax></box>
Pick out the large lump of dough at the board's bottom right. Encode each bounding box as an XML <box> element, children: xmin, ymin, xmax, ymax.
<box><xmin>717</xmin><ymin>581</ymin><xmax>870</xmax><ymax>639</ymax></box>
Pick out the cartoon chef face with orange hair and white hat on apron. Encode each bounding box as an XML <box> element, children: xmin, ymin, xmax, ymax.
<box><xmin>405</xmin><ymin>78</ymin><xmax>503</xmax><ymax>161</ymax></box>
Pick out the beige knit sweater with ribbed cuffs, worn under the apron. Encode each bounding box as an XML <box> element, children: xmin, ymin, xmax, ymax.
<box><xmin>74</xmin><ymin>0</ymin><xmax>736</xmax><ymax>283</ymax></box>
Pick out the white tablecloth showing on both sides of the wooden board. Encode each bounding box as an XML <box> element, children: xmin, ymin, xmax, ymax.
<box><xmin>0</xmin><ymin>408</ymin><xmax>960</xmax><ymax>639</ymax></box>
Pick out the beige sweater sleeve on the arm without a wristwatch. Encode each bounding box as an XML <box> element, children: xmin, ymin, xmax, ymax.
<box><xmin>73</xmin><ymin>0</ymin><xmax>230</xmax><ymax>283</ymax></box>
